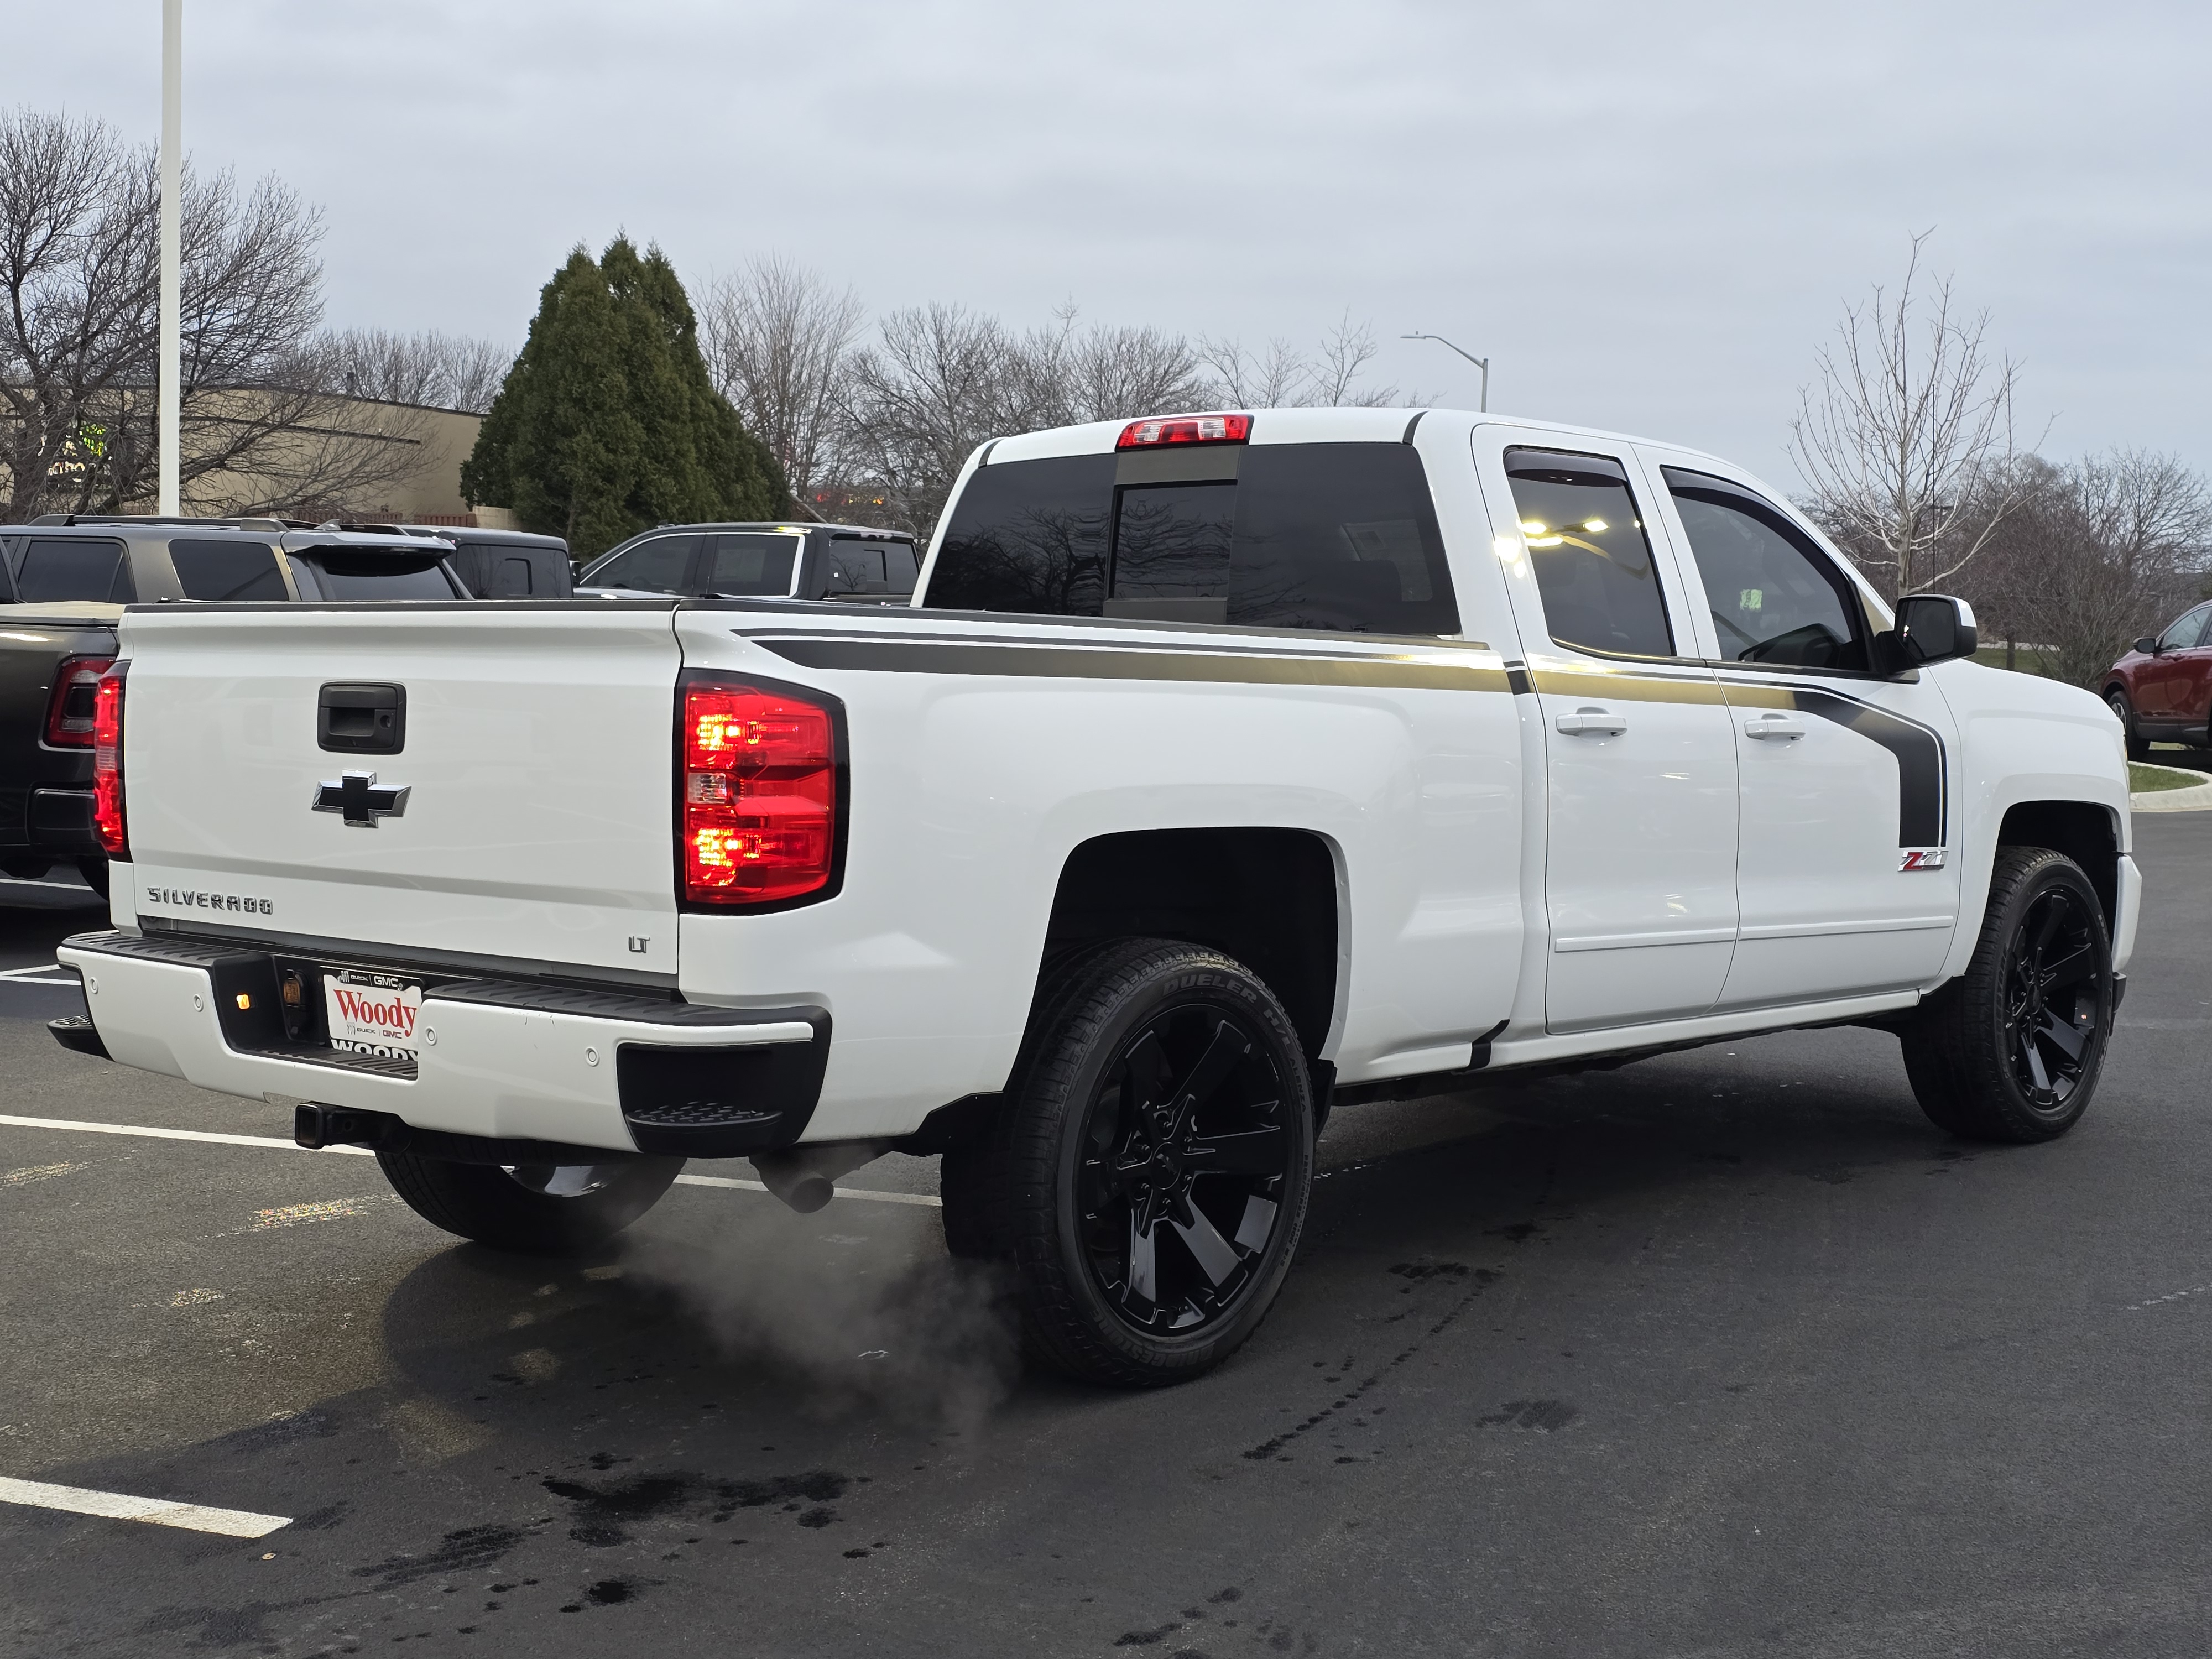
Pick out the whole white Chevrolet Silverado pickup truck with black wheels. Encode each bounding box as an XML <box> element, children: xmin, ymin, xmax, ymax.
<box><xmin>55</xmin><ymin>409</ymin><xmax>2139</xmax><ymax>1385</ymax></box>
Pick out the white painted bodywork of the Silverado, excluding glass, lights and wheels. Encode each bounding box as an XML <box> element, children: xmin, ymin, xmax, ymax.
<box><xmin>64</xmin><ymin>409</ymin><xmax>2141</xmax><ymax>1148</ymax></box>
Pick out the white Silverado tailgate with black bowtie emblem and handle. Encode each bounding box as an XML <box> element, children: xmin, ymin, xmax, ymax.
<box><xmin>117</xmin><ymin>604</ymin><xmax>679</xmax><ymax>975</ymax></box>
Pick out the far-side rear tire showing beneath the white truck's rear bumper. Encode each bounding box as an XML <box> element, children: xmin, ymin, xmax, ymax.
<box><xmin>376</xmin><ymin>1152</ymin><xmax>684</xmax><ymax>1254</ymax></box>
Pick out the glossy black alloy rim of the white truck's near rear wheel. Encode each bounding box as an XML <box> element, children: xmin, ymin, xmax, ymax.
<box><xmin>1075</xmin><ymin>1000</ymin><xmax>1292</xmax><ymax>1336</ymax></box>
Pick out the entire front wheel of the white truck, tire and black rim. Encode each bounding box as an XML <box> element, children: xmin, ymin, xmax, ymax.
<box><xmin>1902</xmin><ymin>847</ymin><xmax>2112</xmax><ymax>1144</ymax></box>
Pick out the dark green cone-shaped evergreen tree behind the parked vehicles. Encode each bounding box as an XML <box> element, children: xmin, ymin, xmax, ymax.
<box><xmin>460</xmin><ymin>237</ymin><xmax>790</xmax><ymax>557</ymax></box>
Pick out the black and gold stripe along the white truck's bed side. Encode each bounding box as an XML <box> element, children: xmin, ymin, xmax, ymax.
<box><xmin>754</xmin><ymin>639</ymin><xmax>1506</xmax><ymax>690</ymax></box>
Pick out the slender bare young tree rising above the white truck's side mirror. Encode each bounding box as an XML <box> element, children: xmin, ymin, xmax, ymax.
<box><xmin>1790</xmin><ymin>232</ymin><xmax>2022</xmax><ymax>593</ymax></box>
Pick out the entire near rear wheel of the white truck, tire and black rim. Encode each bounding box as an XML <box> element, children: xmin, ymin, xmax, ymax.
<box><xmin>942</xmin><ymin>938</ymin><xmax>1314</xmax><ymax>1387</ymax></box>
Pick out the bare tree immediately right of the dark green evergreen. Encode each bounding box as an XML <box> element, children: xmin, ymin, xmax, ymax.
<box><xmin>699</xmin><ymin>257</ymin><xmax>865</xmax><ymax>518</ymax></box>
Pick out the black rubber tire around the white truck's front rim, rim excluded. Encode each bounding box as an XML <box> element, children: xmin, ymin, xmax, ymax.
<box><xmin>1900</xmin><ymin>847</ymin><xmax>2112</xmax><ymax>1144</ymax></box>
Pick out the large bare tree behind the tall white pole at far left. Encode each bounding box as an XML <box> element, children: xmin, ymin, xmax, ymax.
<box><xmin>0</xmin><ymin>108</ymin><xmax>422</xmax><ymax>522</ymax></box>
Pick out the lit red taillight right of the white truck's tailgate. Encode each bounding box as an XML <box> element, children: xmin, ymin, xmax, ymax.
<box><xmin>681</xmin><ymin>681</ymin><xmax>836</xmax><ymax>905</ymax></box>
